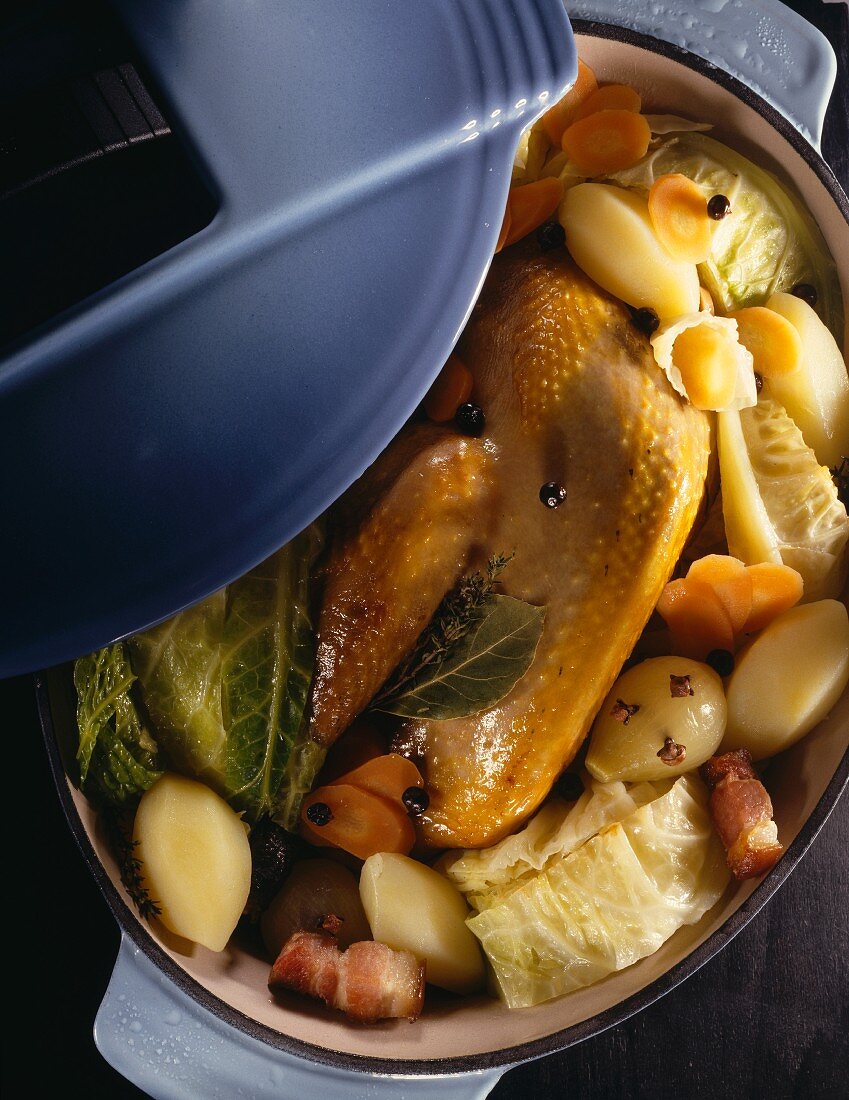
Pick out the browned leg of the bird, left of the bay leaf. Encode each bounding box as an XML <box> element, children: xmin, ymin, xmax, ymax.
<box><xmin>311</xmin><ymin>425</ymin><xmax>494</xmax><ymax>745</ymax></box>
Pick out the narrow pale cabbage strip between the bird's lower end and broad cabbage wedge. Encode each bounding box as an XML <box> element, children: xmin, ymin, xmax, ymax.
<box><xmin>442</xmin><ymin>780</ymin><xmax>662</xmax><ymax>911</ymax></box>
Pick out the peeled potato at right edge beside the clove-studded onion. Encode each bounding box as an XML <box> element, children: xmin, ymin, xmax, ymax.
<box><xmin>721</xmin><ymin>600</ymin><xmax>849</xmax><ymax>760</ymax></box>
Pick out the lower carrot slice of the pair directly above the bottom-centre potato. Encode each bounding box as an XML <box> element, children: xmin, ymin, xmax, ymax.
<box><xmin>300</xmin><ymin>783</ymin><xmax>416</xmax><ymax>859</ymax></box>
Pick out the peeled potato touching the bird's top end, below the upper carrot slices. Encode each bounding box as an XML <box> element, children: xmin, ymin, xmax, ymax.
<box><xmin>560</xmin><ymin>184</ymin><xmax>699</xmax><ymax>321</ymax></box>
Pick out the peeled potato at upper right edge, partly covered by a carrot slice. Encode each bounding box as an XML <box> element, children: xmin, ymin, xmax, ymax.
<box><xmin>763</xmin><ymin>293</ymin><xmax>849</xmax><ymax>466</ymax></box>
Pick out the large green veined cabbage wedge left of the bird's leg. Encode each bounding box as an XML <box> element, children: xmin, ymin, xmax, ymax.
<box><xmin>130</xmin><ymin>527</ymin><xmax>323</xmax><ymax>827</ymax></box>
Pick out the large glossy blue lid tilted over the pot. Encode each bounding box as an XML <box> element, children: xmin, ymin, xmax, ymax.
<box><xmin>0</xmin><ymin>0</ymin><xmax>576</xmax><ymax>675</ymax></box>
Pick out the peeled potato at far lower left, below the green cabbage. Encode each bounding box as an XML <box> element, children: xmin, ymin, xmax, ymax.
<box><xmin>133</xmin><ymin>772</ymin><xmax>251</xmax><ymax>952</ymax></box>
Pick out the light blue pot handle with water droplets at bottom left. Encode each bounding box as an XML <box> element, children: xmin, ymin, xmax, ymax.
<box><xmin>95</xmin><ymin>935</ymin><xmax>508</xmax><ymax>1100</ymax></box>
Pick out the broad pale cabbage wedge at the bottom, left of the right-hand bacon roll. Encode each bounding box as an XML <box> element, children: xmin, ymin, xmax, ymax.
<box><xmin>466</xmin><ymin>776</ymin><xmax>730</xmax><ymax>1009</ymax></box>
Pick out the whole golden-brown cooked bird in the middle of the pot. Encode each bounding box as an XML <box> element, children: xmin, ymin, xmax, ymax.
<box><xmin>310</xmin><ymin>243</ymin><xmax>709</xmax><ymax>847</ymax></box>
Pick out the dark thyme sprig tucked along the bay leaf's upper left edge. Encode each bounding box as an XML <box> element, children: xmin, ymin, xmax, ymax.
<box><xmin>371</xmin><ymin>554</ymin><xmax>514</xmax><ymax>711</ymax></box>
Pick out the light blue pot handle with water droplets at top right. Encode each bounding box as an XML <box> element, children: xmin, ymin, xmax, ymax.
<box><xmin>566</xmin><ymin>0</ymin><xmax>837</xmax><ymax>150</ymax></box>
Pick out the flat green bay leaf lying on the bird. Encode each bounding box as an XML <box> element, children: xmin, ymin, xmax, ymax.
<box><xmin>375</xmin><ymin>593</ymin><xmax>545</xmax><ymax>722</ymax></box>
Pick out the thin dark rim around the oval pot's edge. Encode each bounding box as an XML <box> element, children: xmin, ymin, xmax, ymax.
<box><xmin>34</xmin><ymin>19</ymin><xmax>849</xmax><ymax>1077</ymax></box>
